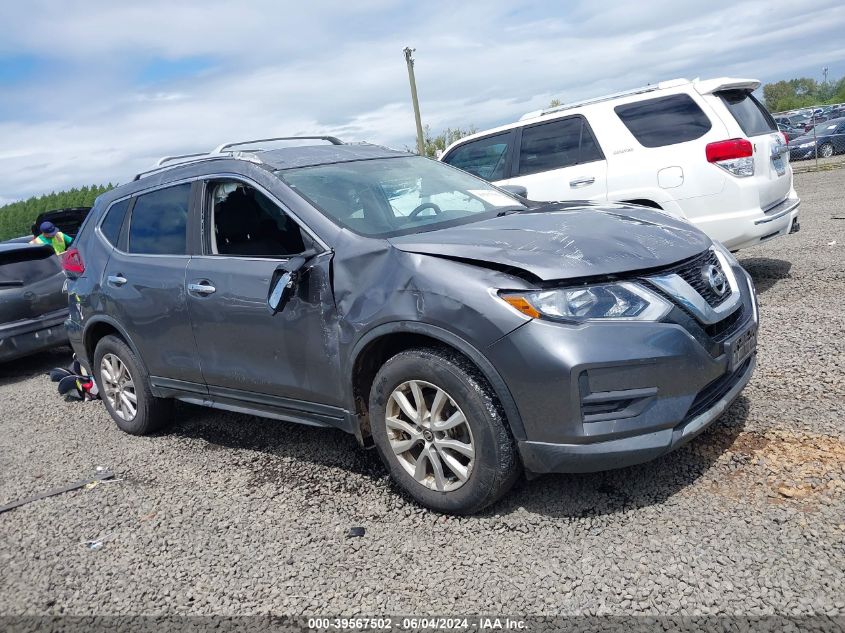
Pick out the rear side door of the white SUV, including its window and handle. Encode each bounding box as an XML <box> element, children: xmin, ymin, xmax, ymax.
<box><xmin>496</xmin><ymin>115</ymin><xmax>607</xmax><ymax>201</ymax></box>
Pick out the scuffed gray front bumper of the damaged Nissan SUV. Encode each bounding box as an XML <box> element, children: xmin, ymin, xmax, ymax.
<box><xmin>487</xmin><ymin>266</ymin><xmax>757</xmax><ymax>473</ymax></box>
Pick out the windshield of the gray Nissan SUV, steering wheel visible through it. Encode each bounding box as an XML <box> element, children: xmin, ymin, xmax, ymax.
<box><xmin>276</xmin><ymin>156</ymin><xmax>525</xmax><ymax>237</ymax></box>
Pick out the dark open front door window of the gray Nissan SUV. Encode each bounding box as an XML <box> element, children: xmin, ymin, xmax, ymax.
<box><xmin>208</xmin><ymin>181</ymin><xmax>305</xmax><ymax>257</ymax></box>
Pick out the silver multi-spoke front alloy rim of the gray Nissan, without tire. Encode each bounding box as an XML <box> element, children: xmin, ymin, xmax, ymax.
<box><xmin>385</xmin><ymin>380</ymin><xmax>475</xmax><ymax>492</ymax></box>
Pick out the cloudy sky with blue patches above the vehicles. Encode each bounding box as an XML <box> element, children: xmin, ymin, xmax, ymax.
<box><xmin>0</xmin><ymin>0</ymin><xmax>845</xmax><ymax>204</ymax></box>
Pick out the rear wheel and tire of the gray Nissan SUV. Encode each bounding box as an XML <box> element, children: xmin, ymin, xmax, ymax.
<box><xmin>93</xmin><ymin>335</ymin><xmax>173</xmax><ymax>435</ymax></box>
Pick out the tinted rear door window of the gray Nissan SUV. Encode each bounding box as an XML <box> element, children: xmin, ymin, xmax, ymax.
<box><xmin>129</xmin><ymin>183</ymin><xmax>191</xmax><ymax>255</ymax></box>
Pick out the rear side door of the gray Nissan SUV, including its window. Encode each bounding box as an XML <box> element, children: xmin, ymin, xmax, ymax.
<box><xmin>100</xmin><ymin>183</ymin><xmax>204</xmax><ymax>391</ymax></box>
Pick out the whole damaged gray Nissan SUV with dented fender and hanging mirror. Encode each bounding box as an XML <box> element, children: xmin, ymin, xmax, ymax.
<box><xmin>63</xmin><ymin>137</ymin><xmax>757</xmax><ymax>513</ymax></box>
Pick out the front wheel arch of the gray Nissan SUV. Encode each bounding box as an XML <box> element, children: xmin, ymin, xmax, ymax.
<box><xmin>346</xmin><ymin>321</ymin><xmax>525</xmax><ymax>446</ymax></box>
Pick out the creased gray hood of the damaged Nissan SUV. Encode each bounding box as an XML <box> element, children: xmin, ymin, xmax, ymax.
<box><xmin>390</xmin><ymin>202</ymin><xmax>711</xmax><ymax>281</ymax></box>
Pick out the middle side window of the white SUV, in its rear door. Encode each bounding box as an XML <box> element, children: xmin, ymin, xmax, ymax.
<box><xmin>518</xmin><ymin>116</ymin><xmax>602</xmax><ymax>176</ymax></box>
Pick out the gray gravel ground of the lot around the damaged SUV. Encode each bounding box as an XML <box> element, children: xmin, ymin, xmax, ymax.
<box><xmin>0</xmin><ymin>169</ymin><xmax>845</xmax><ymax>615</ymax></box>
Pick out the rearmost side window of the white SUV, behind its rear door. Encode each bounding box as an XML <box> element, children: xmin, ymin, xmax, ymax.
<box><xmin>614</xmin><ymin>94</ymin><xmax>711</xmax><ymax>147</ymax></box>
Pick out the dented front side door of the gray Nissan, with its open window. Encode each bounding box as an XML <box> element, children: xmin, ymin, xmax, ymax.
<box><xmin>186</xmin><ymin>180</ymin><xmax>342</xmax><ymax>411</ymax></box>
